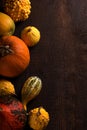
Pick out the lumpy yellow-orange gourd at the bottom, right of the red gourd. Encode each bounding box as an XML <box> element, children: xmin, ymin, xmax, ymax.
<box><xmin>28</xmin><ymin>107</ymin><xmax>50</xmax><ymax>130</ymax></box>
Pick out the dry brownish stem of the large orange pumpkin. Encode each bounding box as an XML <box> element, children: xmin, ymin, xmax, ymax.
<box><xmin>0</xmin><ymin>45</ymin><xmax>14</xmax><ymax>57</ymax></box>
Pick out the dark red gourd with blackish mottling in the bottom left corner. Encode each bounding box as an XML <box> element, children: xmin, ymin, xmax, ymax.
<box><xmin>0</xmin><ymin>96</ymin><xmax>27</xmax><ymax>130</ymax></box>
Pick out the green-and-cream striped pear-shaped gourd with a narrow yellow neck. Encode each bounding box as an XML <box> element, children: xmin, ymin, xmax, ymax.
<box><xmin>21</xmin><ymin>76</ymin><xmax>42</xmax><ymax>110</ymax></box>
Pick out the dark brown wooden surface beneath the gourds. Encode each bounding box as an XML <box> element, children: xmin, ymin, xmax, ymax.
<box><xmin>0</xmin><ymin>0</ymin><xmax>87</xmax><ymax>130</ymax></box>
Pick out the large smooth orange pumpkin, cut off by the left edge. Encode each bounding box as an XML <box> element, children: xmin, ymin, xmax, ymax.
<box><xmin>0</xmin><ymin>36</ymin><xmax>30</xmax><ymax>77</ymax></box>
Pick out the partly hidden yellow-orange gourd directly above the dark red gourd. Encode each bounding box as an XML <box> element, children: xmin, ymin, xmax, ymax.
<box><xmin>0</xmin><ymin>79</ymin><xmax>16</xmax><ymax>97</ymax></box>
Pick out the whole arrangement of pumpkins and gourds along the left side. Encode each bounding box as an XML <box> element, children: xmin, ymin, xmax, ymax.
<box><xmin>0</xmin><ymin>0</ymin><xmax>50</xmax><ymax>130</ymax></box>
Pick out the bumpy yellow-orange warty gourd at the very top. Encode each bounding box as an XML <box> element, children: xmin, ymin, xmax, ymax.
<box><xmin>3</xmin><ymin>0</ymin><xmax>31</xmax><ymax>22</ymax></box>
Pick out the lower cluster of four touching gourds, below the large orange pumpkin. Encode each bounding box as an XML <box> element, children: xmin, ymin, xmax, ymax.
<box><xmin>0</xmin><ymin>76</ymin><xmax>49</xmax><ymax>130</ymax></box>
